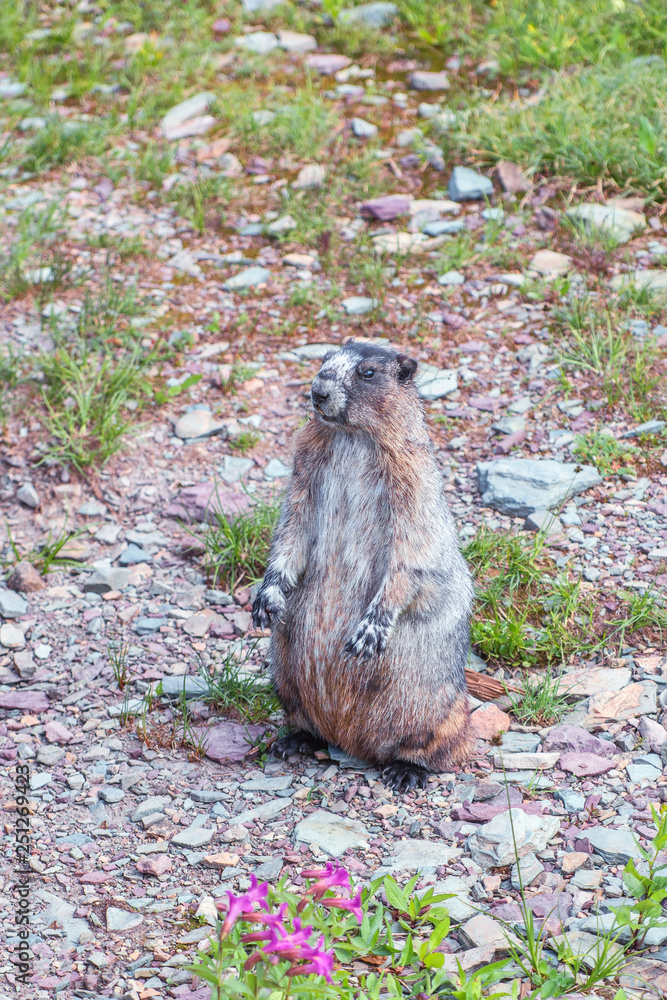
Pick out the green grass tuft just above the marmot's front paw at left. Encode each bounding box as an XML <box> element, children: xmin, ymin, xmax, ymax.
<box><xmin>191</xmin><ymin>498</ymin><xmax>279</xmax><ymax>592</ymax></box>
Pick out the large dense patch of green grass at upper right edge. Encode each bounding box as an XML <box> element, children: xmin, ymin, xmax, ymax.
<box><xmin>445</xmin><ymin>63</ymin><xmax>667</xmax><ymax>197</ymax></box>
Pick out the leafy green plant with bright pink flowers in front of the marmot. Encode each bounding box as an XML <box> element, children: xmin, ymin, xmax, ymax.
<box><xmin>191</xmin><ymin>862</ymin><xmax>456</xmax><ymax>1000</ymax></box>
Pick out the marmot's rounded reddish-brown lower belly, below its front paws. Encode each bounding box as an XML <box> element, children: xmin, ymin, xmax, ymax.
<box><xmin>279</xmin><ymin>588</ymin><xmax>469</xmax><ymax>770</ymax></box>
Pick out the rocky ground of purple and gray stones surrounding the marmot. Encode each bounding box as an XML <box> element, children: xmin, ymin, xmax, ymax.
<box><xmin>0</xmin><ymin>0</ymin><xmax>667</xmax><ymax>1000</ymax></box>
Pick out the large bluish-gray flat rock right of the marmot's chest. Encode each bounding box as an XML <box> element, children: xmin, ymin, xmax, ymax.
<box><xmin>477</xmin><ymin>458</ymin><xmax>602</xmax><ymax>517</ymax></box>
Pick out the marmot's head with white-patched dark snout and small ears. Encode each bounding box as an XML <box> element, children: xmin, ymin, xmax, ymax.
<box><xmin>310</xmin><ymin>341</ymin><xmax>417</xmax><ymax>430</ymax></box>
